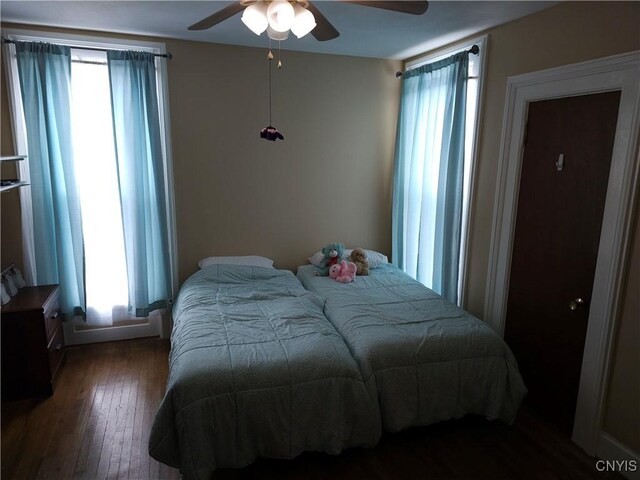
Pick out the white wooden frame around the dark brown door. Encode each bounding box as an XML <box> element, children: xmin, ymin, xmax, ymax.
<box><xmin>484</xmin><ymin>51</ymin><xmax>640</xmax><ymax>455</ymax></box>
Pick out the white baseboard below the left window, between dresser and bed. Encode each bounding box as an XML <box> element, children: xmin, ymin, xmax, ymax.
<box><xmin>63</xmin><ymin>315</ymin><xmax>166</xmax><ymax>346</ymax></box>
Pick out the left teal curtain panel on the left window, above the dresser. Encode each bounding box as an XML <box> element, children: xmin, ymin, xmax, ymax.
<box><xmin>15</xmin><ymin>42</ymin><xmax>85</xmax><ymax>316</ymax></box>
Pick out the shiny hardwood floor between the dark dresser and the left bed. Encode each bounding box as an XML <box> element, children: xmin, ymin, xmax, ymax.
<box><xmin>2</xmin><ymin>339</ymin><xmax>180</xmax><ymax>479</ymax></box>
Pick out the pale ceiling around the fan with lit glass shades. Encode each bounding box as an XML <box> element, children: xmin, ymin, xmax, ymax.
<box><xmin>0</xmin><ymin>0</ymin><xmax>559</xmax><ymax>59</ymax></box>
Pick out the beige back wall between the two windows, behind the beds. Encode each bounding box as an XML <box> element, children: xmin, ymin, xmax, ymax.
<box><xmin>169</xmin><ymin>42</ymin><xmax>400</xmax><ymax>281</ymax></box>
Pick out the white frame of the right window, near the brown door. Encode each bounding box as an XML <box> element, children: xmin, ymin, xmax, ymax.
<box><xmin>404</xmin><ymin>34</ymin><xmax>489</xmax><ymax>308</ymax></box>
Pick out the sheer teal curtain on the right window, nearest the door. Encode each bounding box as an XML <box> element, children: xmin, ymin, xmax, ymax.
<box><xmin>392</xmin><ymin>52</ymin><xmax>469</xmax><ymax>303</ymax></box>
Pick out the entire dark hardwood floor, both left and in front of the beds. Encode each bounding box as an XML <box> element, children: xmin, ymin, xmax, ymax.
<box><xmin>2</xmin><ymin>339</ymin><xmax>622</xmax><ymax>480</ymax></box>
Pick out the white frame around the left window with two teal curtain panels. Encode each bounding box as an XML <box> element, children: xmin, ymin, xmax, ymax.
<box><xmin>3</xmin><ymin>28</ymin><xmax>178</xmax><ymax>310</ymax></box>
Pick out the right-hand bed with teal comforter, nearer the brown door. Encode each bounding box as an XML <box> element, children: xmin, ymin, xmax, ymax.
<box><xmin>297</xmin><ymin>263</ymin><xmax>526</xmax><ymax>432</ymax></box>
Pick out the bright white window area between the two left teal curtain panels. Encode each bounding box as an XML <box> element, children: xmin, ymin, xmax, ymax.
<box><xmin>71</xmin><ymin>54</ymin><xmax>128</xmax><ymax>326</ymax></box>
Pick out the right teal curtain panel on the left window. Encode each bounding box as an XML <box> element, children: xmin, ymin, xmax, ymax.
<box><xmin>107</xmin><ymin>51</ymin><xmax>171</xmax><ymax>317</ymax></box>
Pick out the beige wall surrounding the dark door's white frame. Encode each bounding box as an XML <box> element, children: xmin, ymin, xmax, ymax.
<box><xmin>410</xmin><ymin>2</ymin><xmax>640</xmax><ymax>452</ymax></box>
